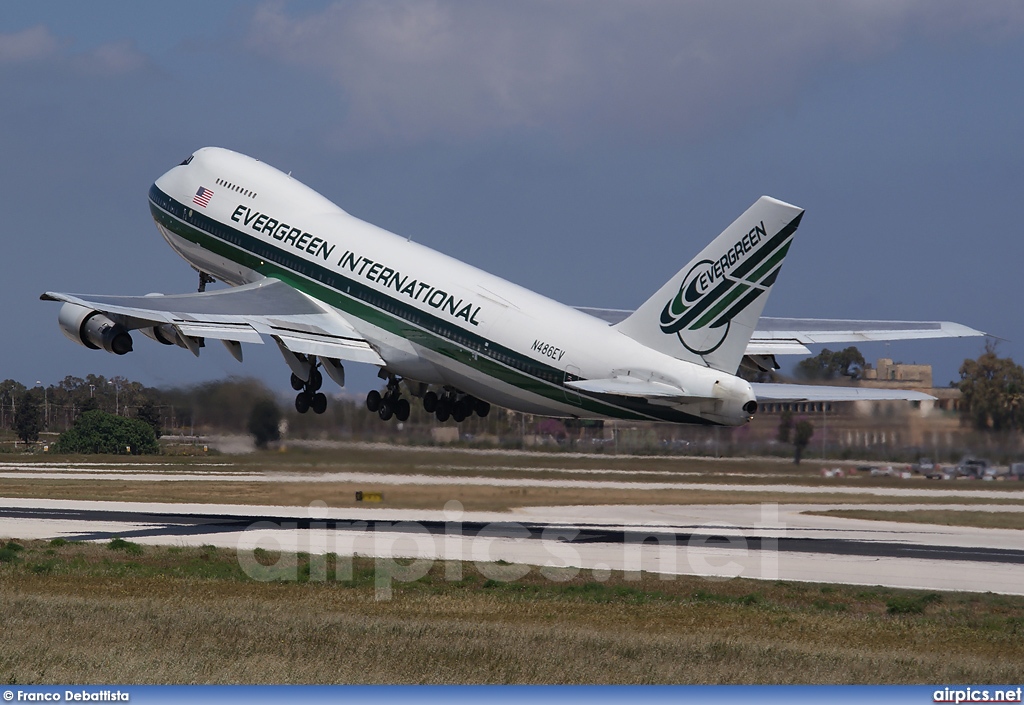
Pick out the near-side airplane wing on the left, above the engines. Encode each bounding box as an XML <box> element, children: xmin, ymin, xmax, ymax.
<box><xmin>40</xmin><ymin>279</ymin><xmax>385</xmax><ymax>365</ymax></box>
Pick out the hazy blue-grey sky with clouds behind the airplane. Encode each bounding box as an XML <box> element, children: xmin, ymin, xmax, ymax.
<box><xmin>0</xmin><ymin>0</ymin><xmax>1024</xmax><ymax>391</ymax></box>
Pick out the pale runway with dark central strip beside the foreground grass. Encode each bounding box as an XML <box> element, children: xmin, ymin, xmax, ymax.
<box><xmin>0</xmin><ymin>493</ymin><xmax>1024</xmax><ymax>594</ymax></box>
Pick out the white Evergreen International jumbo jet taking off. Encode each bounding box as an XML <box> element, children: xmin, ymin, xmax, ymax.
<box><xmin>42</xmin><ymin>148</ymin><xmax>982</xmax><ymax>425</ymax></box>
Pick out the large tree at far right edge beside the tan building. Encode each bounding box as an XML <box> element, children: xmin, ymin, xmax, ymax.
<box><xmin>958</xmin><ymin>342</ymin><xmax>1024</xmax><ymax>431</ymax></box>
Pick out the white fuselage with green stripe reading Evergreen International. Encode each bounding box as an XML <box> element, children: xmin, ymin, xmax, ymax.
<box><xmin>150</xmin><ymin>148</ymin><xmax>755</xmax><ymax>425</ymax></box>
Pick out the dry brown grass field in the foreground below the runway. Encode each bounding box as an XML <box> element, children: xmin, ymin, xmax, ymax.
<box><xmin>0</xmin><ymin>542</ymin><xmax>1024</xmax><ymax>683</ymax></box>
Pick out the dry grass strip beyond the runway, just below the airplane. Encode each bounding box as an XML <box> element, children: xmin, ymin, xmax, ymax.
<box><xmin>0</xmin><ymin>445</ymin><xmax>1024</xmax><ymax>511</ymax></box>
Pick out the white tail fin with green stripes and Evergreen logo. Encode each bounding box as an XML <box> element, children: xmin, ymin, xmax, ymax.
<box><xmin>615</xmin><ymin>196</ymin><xmax>804</xmax><ymax>374</ymax></box>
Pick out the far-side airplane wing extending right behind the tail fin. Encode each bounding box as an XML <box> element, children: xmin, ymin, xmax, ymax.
<box><xmin>577</xmin><ymin>306</ymin><xmax>985</xmax><ymax>356</ymax></box>
